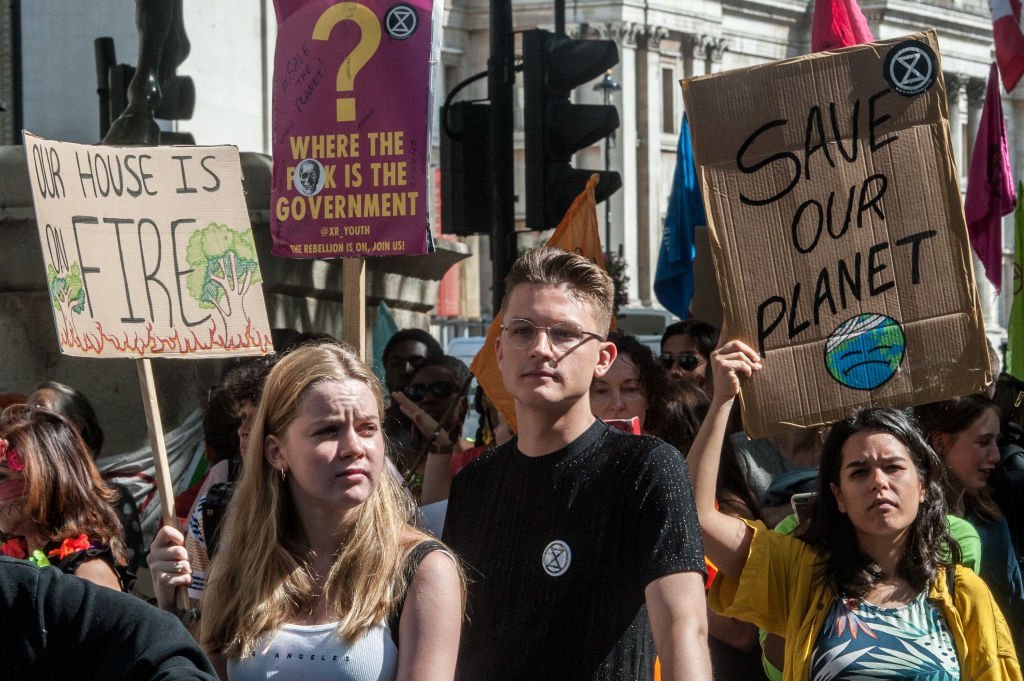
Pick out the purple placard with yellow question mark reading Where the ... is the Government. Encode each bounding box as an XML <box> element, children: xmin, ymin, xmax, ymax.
<box><xmin>271</xmin><ymin>0</ymin><xmax>440</xmax><ymax>258</ymax></box>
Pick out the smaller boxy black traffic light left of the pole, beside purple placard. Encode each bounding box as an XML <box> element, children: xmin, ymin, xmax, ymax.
<box><xmin>440</xmin><ymin>101</ymin><xmax>494</xmax><ymax>237</ymax></box>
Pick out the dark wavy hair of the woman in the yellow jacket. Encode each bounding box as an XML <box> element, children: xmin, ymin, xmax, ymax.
<box><xmin>801</xmin><ymin>409</ymin><xmax>961</xmax><ymax>598</ymax></box>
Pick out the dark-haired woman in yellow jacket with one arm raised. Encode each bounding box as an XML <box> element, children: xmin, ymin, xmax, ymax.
<box><xmin>688</xmin><ymin>341</ymin><xmax>1021</xmax><ymax>681</ymax></box>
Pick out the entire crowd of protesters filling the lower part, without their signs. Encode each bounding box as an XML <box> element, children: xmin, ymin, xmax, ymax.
<box><xmin>0</xmin><ymin>249</ymin><xmax>1024</xmax><ymax>681</ymax></box>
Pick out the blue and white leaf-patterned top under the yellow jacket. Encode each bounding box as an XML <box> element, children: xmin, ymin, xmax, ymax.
<box><xmin>811</xmin><ymin>591</ymin><xmax>961</xmax><ymax>681</ymax></box>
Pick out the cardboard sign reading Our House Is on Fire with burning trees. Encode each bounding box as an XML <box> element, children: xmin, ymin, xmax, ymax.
<box><xmin>25</xmin><ymin>133</ymin><xmax>272</xmax><ymax>358</ymax></box>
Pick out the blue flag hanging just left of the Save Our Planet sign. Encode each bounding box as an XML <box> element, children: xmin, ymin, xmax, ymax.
<box><xmin>654</xmin><ymin>114</ymin><xmax>708</xmax><ymax>320</ymax></box>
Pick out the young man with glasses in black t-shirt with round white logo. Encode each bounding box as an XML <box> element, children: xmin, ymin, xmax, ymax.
<box><xmin>444</xmin><ymin>248</ymin><xmax>712</xmax><ymax>681</ymax></box>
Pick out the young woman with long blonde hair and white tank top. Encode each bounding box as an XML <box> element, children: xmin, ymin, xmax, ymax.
<box><xmin>194</xmin><ymin>344</ymin><xmax>464</xmax><ymax>681</ymax></box>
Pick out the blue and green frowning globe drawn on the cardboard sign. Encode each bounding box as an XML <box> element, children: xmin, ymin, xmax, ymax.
<box><xmin>825</xmin><ymin>313</ymin><xmax>906</xmax><ymax>390</ymax></box>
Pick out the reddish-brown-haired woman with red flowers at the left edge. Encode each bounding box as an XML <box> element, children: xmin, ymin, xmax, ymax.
<box><xmin>0</xmin><ymin>405</ymin><xmax>127</xmax><ymax>591</ymax></box>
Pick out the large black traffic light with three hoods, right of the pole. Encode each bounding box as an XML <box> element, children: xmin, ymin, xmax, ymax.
<box><xmin>522</xmin><ymin>30</ymin><xmax>623</xmax><ymax>229</ymax></box>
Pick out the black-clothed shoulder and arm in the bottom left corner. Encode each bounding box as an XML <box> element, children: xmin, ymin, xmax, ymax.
<box><xmin>0</xmin><ymin>558</ymin><xmax>217</xmax><ymax>681</ymax></box>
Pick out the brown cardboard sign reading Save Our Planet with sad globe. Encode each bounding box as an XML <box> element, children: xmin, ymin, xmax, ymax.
<box><xmin>683</xmin><ymin>31</ymin><xmax>991</xmax><ymax>436</ymax></box>
